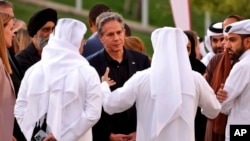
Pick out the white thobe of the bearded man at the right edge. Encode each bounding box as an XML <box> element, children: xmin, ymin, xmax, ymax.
<box><xmin>221</xmin><ymin>50</ymin><xmax>250</xmax><ymax>141</ymax></box>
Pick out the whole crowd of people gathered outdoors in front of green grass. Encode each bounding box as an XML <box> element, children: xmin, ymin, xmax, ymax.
<box><xmin>0</xmin><ymin>0</ymin><xmax>250</xmax><ymax>141</ymax></box>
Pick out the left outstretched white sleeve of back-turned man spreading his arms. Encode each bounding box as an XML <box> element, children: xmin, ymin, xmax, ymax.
<box><xmin>102</xmin><ymin>74</ymin><xmax>136</xmax><ymax>115</ymax></box>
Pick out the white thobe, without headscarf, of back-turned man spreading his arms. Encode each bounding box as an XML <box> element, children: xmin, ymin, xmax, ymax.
<box><xmin>102</xmin><ymin>69</ymin><xmax>221</xmax><ymax>141</ymax></box>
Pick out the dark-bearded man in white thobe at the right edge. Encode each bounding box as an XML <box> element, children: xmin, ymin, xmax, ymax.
<box><xmin>217</xmin><ymin>19</ymin><xmax>250</xmax><ymax>141</ymax></box>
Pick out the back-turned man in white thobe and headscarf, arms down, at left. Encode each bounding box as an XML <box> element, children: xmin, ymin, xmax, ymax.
<box><xmin>15</xmin><ymin>18</ymin><xmax>102</xmax><ymax>141</ymax></box>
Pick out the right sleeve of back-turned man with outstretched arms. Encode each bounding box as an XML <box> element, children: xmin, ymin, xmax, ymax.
<box><xmin>192</xmin><ymin>73</ymin><xmax>221</xmax><ymax>119</ymax></box>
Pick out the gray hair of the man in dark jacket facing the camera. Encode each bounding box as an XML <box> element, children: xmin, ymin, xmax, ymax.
<box><xmin>96</xmin><ymin>12</ymin><xmax>124</xmax><ymax>35</ymax></box>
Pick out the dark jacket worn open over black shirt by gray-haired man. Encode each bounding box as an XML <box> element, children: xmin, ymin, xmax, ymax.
<box><xmin>87</xmin><ymin>49</ymin><xmax>150</xmax><ymax>141</ymax></box>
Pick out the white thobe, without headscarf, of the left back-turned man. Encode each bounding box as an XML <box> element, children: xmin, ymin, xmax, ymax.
<box><xmin>15</xmin><ymin>62</ymin><xmax>102</xmax><ymax>141</ymax></box>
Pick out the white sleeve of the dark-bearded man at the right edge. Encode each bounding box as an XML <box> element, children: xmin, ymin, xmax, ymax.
<box><xmin>221</xmin><ymin>64</ymin><xmax>249</xmax><ymax>115</ymax></box>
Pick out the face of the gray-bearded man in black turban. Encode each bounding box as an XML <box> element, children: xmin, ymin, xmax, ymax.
<box><xmin>34</xmin><ymin>21</ymin><xmax>55</xmax><ymax>50</ymax></box>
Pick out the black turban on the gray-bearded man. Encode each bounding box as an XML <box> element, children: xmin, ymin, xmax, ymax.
<box><xmin>27</xmin><ymin>8</ymin><xmax>57</xmax><ymax>37</ymax></box>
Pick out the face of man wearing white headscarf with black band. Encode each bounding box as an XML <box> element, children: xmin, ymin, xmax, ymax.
<box><xmin>210</xmin><ymin>35</ymin><xmax>224</xmax><ymax>54</ymax></box>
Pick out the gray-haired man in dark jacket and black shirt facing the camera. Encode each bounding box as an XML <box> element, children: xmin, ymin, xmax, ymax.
<box><xmin>87</xmin><ymin>12</ymin><xmax>150</xmax><ymax>141</ymax></box>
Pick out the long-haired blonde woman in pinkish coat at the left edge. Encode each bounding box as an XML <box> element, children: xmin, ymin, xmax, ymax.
<box><xmin>0</xmin><ymin>12</ymin><xmax>16</xmax><ymax>141</ymax></box>
